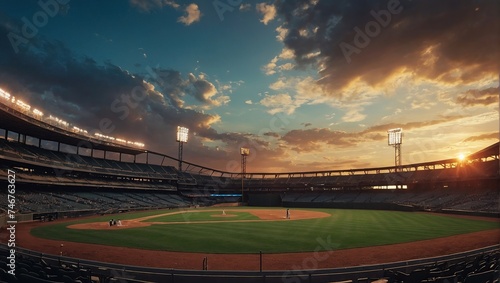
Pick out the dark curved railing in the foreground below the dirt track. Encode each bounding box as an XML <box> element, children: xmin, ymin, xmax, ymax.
<box><xmin>0</xmin><ymin>244</ymin><xmax>500</xmax><ymax>283</ymax></box>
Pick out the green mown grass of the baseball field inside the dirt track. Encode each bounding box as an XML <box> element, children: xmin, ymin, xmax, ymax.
<box><xmin>32</xmin><ymin>209</ymin><xmax>500</xmax><ymax>253</ymax></box>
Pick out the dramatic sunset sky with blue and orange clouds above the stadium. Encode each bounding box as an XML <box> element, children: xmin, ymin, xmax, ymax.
<box><xmin>0</xmin><ymin>0</ymin><xmax>500</xmax><ymax>172</ymax></box>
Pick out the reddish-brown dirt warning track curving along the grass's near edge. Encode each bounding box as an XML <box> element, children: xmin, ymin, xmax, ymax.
<box><xmin>0</xmin><ymin>212</ymin><xmax>500</xmax><ymax>270</ymax></box>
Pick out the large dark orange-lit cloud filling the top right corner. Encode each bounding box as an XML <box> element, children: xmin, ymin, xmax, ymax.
<box><xmin>275</xmin><ymin>0</ymin><xmax>500</xmax><ymax>97</ymax></box>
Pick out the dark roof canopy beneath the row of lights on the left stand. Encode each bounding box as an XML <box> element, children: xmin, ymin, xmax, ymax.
<box><xmin>0</xmin><ymin>103</ymin><xmax>147</xmax><ymax>155</ymax></box>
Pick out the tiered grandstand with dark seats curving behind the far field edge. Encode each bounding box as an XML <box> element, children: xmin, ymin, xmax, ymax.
<box><xmin>0</xmin><ymin>96</ymin><xmax>500</xmax><ymax>282</ymax></box>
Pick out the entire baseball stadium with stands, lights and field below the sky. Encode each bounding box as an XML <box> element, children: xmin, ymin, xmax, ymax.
<box><xmin>0</xmin><ymin>86</ymin><xmax>500</xmax><ymax>282</ymax></box>
